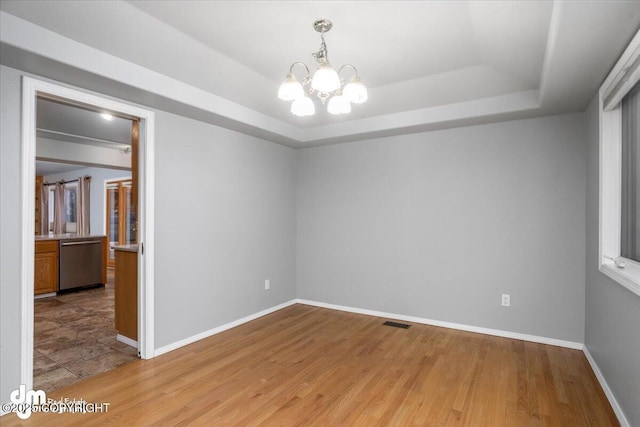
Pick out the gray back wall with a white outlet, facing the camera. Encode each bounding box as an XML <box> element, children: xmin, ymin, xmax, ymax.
<box><xmin>297</xmin><ymin>114</ymin><xmax>585</xmax><ymax>342</ymax></box>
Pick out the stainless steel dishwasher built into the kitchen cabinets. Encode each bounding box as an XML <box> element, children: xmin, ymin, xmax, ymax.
<box><xmin>60</xmin><ymin>237</ymin><xmax>102</xmax><ymax>291</ymax></box>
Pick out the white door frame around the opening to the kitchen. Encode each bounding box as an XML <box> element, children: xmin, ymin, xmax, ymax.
<box><xmin>20</xmin><ymin>76</ymin><xmax>155</xmax><ymax>389</ymax></box>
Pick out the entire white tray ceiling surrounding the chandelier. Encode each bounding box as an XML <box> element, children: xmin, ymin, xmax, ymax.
<box><xmin>0</xmin><ymin>0</ymin><xmax>640</xmax><ymax>147</ymax></box>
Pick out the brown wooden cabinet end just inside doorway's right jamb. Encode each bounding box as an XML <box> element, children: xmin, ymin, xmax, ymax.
<box><xmin>113</xmin><ymin>245</ymin><xmax>138</xmax><ymax>341</ymax></box>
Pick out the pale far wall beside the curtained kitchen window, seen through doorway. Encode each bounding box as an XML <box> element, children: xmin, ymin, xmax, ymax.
<box><xmin>44</xmin><ymin>167</ymin><xmax>131</xmax><ymax>234</ymax></box>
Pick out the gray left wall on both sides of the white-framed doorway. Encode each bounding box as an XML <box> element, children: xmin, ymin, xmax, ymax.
<box><xmin>0</xmin><ymin>66</ymin><xmax>296</xmax><ymax>402</ymax></box>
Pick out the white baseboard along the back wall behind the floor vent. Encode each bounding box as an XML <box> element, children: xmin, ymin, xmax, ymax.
<box><xmin>296</xmin><ymin>299</ymin><xmax>584</xmax><ymax>350</ymax></box>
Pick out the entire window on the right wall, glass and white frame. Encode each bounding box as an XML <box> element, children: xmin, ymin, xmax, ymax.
<box><xmin>599</xmin><ymin>28</ymin><xmax>640</xmax><ymax>295</ymax></box>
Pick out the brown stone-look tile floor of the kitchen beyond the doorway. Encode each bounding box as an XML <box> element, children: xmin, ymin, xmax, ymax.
<box><xmin>33</xmin><ymin>269</ymin><xmax>138</xmax><ymax>393</ymax></box>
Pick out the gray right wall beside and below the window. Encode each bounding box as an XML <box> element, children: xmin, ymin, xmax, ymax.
<box><xmin>585</xmin><ymin>97</ymin><xmax>640</xmax><ymax>426</ymax></box>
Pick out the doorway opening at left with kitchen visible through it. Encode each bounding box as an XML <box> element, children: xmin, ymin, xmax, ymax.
<box><xmin>33</xmin><ymin>115</ymin><xmax>138</xmax><ymax>392</ymax></box>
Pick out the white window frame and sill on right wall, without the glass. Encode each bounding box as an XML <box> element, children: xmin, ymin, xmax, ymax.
<box><xmin>598</xmin><ymin>27</ymin><xmax>640</xmax><ymax>296</ymax></box>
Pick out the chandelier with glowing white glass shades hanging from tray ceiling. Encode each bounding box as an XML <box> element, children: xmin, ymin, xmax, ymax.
<box><xmin>278</xmin><ymin>19</ymin><xmax>367</xmax><ymax>116</ymax></box>
